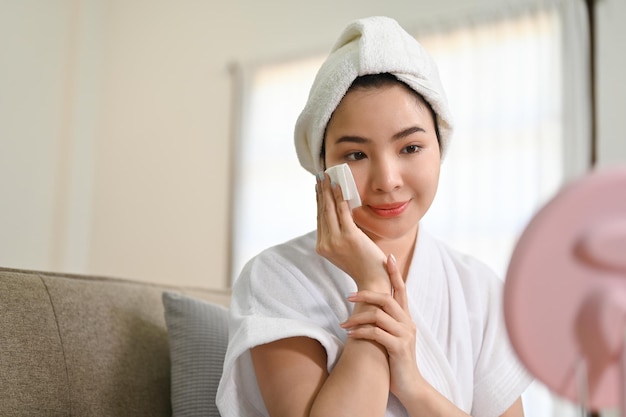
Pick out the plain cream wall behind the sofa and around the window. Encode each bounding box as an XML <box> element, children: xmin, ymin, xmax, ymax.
<box><xmin>0</xmin><ymin>0</ymin><xmax>626</xmax><ymax>287</ymax></box>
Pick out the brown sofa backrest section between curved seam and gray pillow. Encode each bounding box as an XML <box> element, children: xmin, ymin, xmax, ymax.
<box><xmin>42</xmin><ymin>275</ymin><xmax>171</xmax><ymax>417</ymax></box>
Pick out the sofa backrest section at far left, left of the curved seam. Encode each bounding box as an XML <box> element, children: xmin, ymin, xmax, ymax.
<box><xmin>0</xmin><ymin>270</ymin><xmax>70</xmax><ymax>416</ymax></box>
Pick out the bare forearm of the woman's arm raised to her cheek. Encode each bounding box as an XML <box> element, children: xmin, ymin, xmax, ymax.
<box><xmin>311</xmin><ymin>284</ymin><xmax>390</xmax><ymax>417</ymax></box>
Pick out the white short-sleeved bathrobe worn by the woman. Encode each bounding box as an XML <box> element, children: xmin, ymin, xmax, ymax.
<box><xmin>217</xmin><ymin>227</ymin><xmax>531</xmax><ymax>417</ymax></box>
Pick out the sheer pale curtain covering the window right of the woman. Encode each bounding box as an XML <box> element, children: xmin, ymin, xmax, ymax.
<box><xmin>414</xmin><ymin>0</ymin><xmax>591</xmax><ymax>417</ymax></box>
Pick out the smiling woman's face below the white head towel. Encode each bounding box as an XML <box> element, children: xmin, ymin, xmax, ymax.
<box><xmin>325</xmin><ymin>84</ymin><xmax>441</xmax><ymax>242</ymax></box>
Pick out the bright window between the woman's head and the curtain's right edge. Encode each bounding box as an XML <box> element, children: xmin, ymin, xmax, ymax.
<box><xmin>420</xmin><ymin>11</ymin><xmax>564</xmax><ymax>276</ymax></box>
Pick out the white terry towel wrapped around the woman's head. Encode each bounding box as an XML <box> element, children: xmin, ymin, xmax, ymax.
<box><xmin>294</xmin><ymin>16</ymin><xmax>452</xmax><ymax>174</ymax></box>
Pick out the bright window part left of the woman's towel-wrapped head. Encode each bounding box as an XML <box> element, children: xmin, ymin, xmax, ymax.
<box><xmin>232</xmin><ymin>52</ymin><xmax>325</xmax><ymax>280</ymax></box>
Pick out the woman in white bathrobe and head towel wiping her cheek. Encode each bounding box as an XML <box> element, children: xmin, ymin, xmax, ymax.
<box><xmin>218</xmin><ymin>17</ymin><xmax>530</xmax><ymax>417</ymax></box>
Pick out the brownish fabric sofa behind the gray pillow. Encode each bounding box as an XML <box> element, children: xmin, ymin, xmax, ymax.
<box><xmin>0</xmin><ymin>268</ymin><xmax>229</xmax><ymax>417</ymax></box>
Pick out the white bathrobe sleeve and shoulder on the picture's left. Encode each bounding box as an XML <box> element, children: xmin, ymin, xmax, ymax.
<box><xmin>217</xmin><ymin>240</ymin><xmax>349</xmax><ymax>417</ymax></box>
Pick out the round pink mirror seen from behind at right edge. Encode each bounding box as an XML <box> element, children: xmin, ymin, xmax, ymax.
<box><xmin>503</xmin><ymin>167</ymin><xmax>626</xmax><ymax>416</ymax></box>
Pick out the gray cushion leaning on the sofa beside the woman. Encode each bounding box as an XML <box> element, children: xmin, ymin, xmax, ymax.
<box><xmin>163</xmin><ymin>291</ymin><xmax>228</xmax><ymax>417</ymax></box>
